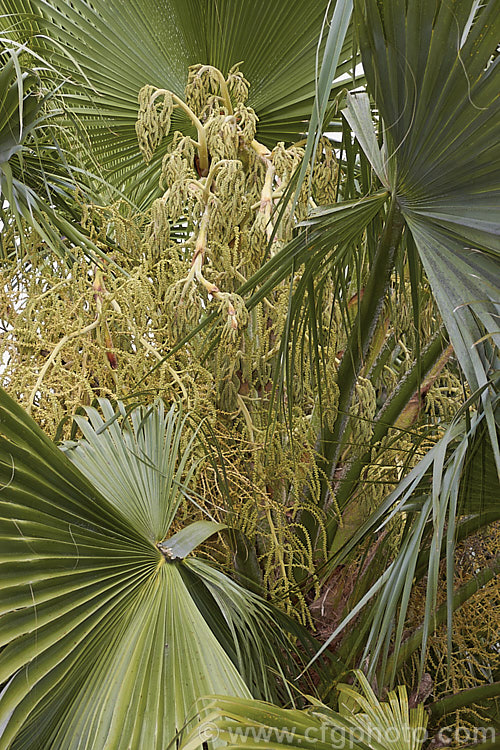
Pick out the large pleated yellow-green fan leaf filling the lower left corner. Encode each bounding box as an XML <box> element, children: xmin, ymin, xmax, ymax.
<box><xmin>0</xmin><ymin>392</ymin><xmax>276</xmax><ymax>750</ymax></box>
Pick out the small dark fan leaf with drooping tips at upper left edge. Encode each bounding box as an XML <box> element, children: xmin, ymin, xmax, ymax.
<box><xmin>0</xmin><ymin>46</ymin><xmax>125</xmax><ymax>260</ymax></box>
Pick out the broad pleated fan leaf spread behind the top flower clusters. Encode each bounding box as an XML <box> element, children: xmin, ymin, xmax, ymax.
<box><xmin>16</xmin><ymin>0</ymin><xmax>352</xmax><ymax>203</ymax></box>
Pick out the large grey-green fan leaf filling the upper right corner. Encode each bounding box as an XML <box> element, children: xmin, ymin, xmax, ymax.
<box><xmin>356</xmin><ymin>0</ymin><xmax>500</xmax><ymax>406</ymax></box>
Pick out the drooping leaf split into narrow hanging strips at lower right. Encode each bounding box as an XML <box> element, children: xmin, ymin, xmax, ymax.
<box><xmin>311</xmin><ymin>400</ymin><xmax>500</xmax><ymax>684</ymax></box>
